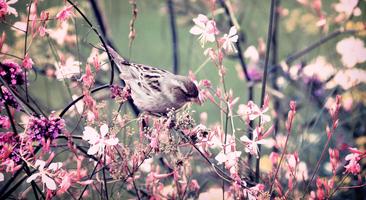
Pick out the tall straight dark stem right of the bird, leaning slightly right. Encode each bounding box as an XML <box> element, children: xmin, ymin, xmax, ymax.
<box><xmin>255</xmin><ymin>0</ymin><xmax>276</xmax><ymax>182</ymax></box>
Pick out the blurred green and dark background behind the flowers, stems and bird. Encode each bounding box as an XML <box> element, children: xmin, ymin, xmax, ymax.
<box><xmin>0</xmin><ymin>0</ymin><xmax>366</xmax><ymax>198</ymax></box>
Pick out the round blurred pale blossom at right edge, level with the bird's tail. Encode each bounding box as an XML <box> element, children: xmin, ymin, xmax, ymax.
<box><xmin>336</xmin><ymin>36</ymin><xmax>366</xmax><ymax>68</ymax></box>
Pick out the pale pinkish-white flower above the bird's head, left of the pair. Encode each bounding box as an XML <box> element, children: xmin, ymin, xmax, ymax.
<box><xmin>189</xmin><ymin>14</ymin><xmax>219</xmax><ymax>47</ymax></box>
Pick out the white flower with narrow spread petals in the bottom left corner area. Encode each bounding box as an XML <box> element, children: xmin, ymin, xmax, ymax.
<box><xmin>27</xmin><ymin>160</ymin><xmax>62</xmax><ymax>190</ymax></box>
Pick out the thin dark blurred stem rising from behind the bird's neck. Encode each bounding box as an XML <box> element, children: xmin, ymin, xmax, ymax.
<box><xmin>167</xmin><ymin>0</ymin><xmax>179</xmax><ymax>74</ymax></box>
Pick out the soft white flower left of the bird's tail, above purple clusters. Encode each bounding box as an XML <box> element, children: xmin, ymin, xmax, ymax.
<box><xmin>55</xmin><ymin>57</ymin><xmax>81</xmax><ymax>80</ymax></box>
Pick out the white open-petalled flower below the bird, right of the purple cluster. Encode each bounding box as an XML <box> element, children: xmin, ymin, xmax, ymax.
<box><xmin>83</xmin><ymin>124</ymin><xmax>118</xmax><ymax>155</ymax></box>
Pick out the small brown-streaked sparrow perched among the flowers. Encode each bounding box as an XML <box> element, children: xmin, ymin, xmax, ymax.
<box><xmin>106</xmin><ymin>45</ymin><xmax>201</xmax><ymax>116</ymax></box>
